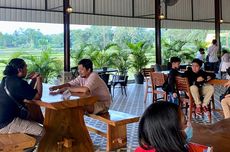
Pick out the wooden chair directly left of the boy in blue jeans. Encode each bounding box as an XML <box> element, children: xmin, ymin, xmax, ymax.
<box><xmin>150</xmin><ymin>72</ymin><xmax>167</xmax><ymax>102</ymax></box>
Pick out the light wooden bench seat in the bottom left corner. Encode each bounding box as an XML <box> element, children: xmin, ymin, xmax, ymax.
<box><xmin>0</xmin><ymin>133</ymin><xmax>36</xmax><ymax>152</ymax></box>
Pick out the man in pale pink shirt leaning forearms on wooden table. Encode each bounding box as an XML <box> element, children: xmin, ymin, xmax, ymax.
<box><xmin>50</xmin><ymin>59</ymin><xmax>111</xmax><ymax>114</ymax></box>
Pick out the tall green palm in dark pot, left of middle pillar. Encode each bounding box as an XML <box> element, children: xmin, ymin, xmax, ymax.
<box><xmin>127</xmin><ymin>42</ymin><xmax>149</xmax><ymax>84</ymax></box>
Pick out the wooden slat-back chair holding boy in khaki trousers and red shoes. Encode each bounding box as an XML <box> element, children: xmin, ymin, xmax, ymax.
<box><xmin>176</xmin><ymin>76</ymin><xmax>214</xmax><ymax>122</ymax></box>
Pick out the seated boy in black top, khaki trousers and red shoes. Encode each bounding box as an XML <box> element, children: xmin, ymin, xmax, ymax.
<box><xmin>185</xmin><ymin>59</ymin><xmax>215</xmax><ymax>115</ymax></box>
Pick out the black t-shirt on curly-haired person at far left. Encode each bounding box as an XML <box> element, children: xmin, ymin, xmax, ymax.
<box><xmin>0</xmin><ymin>76</ymin><xmax>37</xmax><ymax>128</ymax></box>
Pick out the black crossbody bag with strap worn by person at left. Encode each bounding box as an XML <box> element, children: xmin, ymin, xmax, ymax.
<box><xmin>4</xmin><ymin>78</ymin><xmax>29</xmax><ymax>119</ymax></box>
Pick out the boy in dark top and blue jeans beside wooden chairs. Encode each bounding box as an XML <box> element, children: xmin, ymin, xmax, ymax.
<box><xmin>167</xmin><ymin>57</ymin><xmax>181</xmax><ymax>105</ymax></box>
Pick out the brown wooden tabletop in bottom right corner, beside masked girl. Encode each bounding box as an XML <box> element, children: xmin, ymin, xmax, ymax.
<box><xmin>192</xmin><ymin>119</ymin><xmax>230</xmax><ymax>152</ymax></box>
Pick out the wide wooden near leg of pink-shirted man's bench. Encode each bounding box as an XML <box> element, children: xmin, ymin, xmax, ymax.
<box><xmin>106</xmin><ymin>124</ymin><xmax>127</xmax><ymax>151</ymax></box>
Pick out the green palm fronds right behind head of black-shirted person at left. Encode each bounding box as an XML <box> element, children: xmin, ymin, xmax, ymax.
<box><xmin>24</xmin><ymin>49</ymin><xmax>63</xmax><ymax>83</ymax></box>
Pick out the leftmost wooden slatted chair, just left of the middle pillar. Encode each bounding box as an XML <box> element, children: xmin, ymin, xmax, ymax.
<box><xmin>142</xmin><ymin>68</ymin><xmax>154</xmax><ymax>102</ymax></box>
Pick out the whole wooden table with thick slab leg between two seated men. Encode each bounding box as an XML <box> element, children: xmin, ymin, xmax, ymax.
<box><xmin>33</xmin><ymin>85</ymin><xmax>97</xmax><ymax>152</ymax></box>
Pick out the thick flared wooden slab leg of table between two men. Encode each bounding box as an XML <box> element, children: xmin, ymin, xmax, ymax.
<box><xmin>38</xmin><ymin>107</ymin><xmax>93</xmax><ymax>152</ymax></box>
